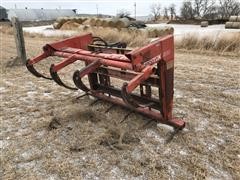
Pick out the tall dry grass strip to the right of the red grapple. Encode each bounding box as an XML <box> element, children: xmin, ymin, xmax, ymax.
<box><xmin>176</xmin><ymin>32</ymin><xmax>240</xmax><ymax>55</ymax></box>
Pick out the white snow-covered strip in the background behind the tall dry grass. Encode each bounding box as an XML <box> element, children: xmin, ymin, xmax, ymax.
<box><xmin>23</xmin><ymin>23</ymin><xmax>240</xmax><ymax>37</ymax></box>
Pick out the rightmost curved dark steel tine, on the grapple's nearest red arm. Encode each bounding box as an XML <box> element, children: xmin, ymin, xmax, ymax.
<box><xmin>121</xmin><ymin>82</ymin><xmax>154</xmax><ymax>108</ymax></box>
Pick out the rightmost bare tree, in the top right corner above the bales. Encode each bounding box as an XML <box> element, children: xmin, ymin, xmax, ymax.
<box><xmin>219</xmin><ymin>0</ymin><xmax>240</xmax><ymax>19</ymax></box>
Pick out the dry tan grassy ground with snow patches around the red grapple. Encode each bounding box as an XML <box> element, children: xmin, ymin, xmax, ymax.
<box><xmin>0</xmin><ymin>34</ymin><xmax>240</xmax><ymax>180</ymax></box>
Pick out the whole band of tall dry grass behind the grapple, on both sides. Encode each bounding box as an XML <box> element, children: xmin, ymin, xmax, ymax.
<box><xmin>0</xmin><ymin>25</ymin><xmax>240</xmax><ymax>52</ymax></box>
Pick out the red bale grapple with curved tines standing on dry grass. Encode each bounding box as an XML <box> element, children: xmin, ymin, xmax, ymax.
<box><xmin>26</xmin><ymin>34</ymin><xmax>185</xmax><ymax>129</ymax></box>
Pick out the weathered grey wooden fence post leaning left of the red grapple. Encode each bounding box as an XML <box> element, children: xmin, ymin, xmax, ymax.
<box><xmin>11</xmin><ymin>17</ymin><xmax>27</xmax><ymax>64</ymax></box>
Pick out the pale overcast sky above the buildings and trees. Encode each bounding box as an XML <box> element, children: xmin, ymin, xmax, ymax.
<box><xmin>0</xmin><ymin>0</ymin><xmax>186</xmax><ymax>16</ymax></box>
